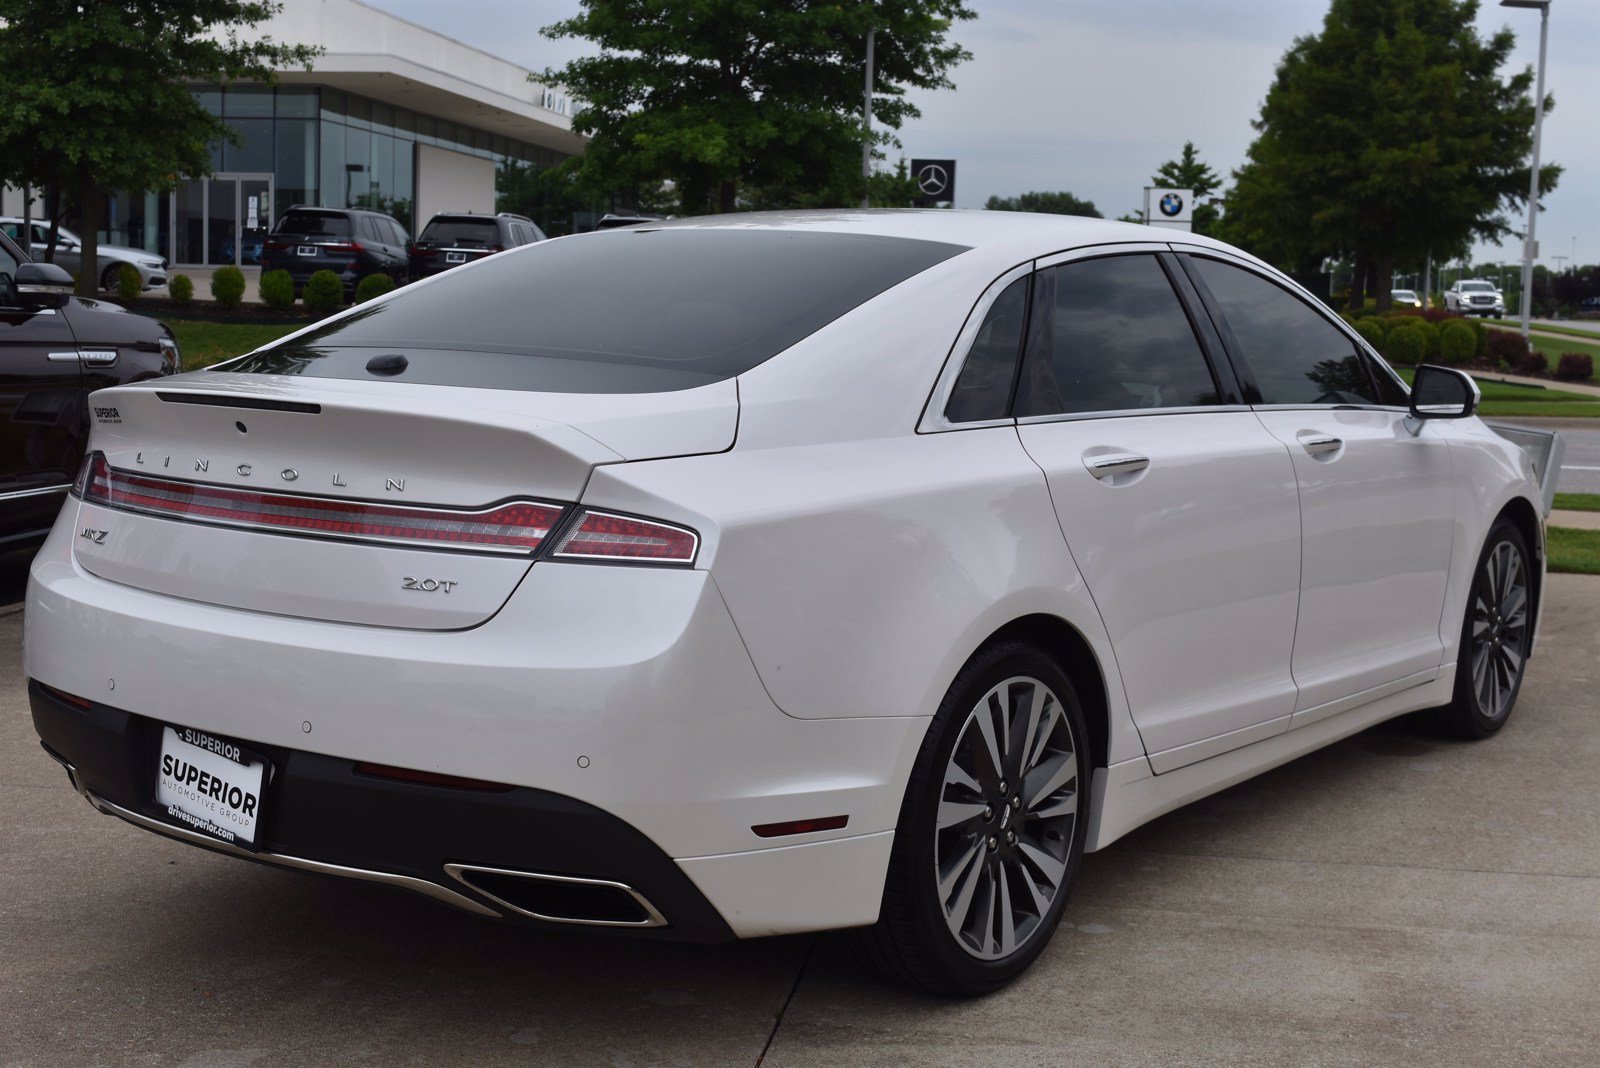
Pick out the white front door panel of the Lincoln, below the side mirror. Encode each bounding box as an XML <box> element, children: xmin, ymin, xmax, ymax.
<box><xmin>1256</xmin><ymin>408</ymin><xmax>1454</xmax><ymax>710</ymax></box>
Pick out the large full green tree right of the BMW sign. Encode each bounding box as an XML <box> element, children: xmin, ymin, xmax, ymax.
<box><xmin>1221</xmin><ymin>0</ymin><xmax>1560</xmax><ymax>314</ymax></box>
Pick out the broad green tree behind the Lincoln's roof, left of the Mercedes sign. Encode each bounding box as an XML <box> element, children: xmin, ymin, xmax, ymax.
<box><xmin>538</xmin><ymin>0</ymin><xmax>973</xmax><ymax>214</ymax></box>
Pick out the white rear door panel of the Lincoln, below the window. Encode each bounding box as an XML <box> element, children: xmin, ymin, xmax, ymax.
<box><xmin>1018</xmin><ymin>411</ymin><xmax>1301</xmax><ymax>757</ymax></box>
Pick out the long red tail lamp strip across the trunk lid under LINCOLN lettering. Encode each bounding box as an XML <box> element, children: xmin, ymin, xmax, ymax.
<box><xmin>83</xmin><ymin>456</ymin><xmax>562</xmax><ymax>553</ymax></box>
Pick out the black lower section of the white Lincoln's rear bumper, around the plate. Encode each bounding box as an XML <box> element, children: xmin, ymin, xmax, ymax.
<box><xmin>29</xmin><ymin>679</ymin><xmax>733</xmax><ymax>942</ymax></box>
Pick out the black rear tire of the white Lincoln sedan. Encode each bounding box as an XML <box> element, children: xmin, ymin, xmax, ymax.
<box><xmin>846</xmin><ymin>640</ymin><xmax>1090</xmax><ymax>998</ymax></box>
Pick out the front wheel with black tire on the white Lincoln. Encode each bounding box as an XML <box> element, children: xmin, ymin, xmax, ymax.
<box><xmin>1438</xmin><ymin>518</ymin><xmax>1534</xmax><ymax>740</ymax></box>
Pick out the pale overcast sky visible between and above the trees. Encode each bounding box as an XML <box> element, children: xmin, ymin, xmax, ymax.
<box><xmin>368</xmin><ymin>0</ymin><xmax>1600</xmax><ymax>267</ymax></box>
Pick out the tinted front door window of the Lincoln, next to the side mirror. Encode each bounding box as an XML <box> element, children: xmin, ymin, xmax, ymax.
<box><xmin>1190</xmin><ymin>256</ymin><xmax>1378</xmax><ymax>404</ymax></box>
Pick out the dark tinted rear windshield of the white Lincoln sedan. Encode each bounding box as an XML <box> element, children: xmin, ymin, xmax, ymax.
<box><xmin>227</xmin><ymin>227</ymin><xmax>965</xmax><ymax>393</ymax></box>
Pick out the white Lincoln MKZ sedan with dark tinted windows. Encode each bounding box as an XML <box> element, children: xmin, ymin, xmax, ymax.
<box><xmin>26</xmin><ymin>211</ymin><xmax>1544</xmax><ymax>994</ymax></box>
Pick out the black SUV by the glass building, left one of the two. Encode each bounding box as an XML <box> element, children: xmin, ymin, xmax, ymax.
<box><xmin>261</xmin><ymin>205</ymin><xmax>411</xmax><ymax>297</ymax></box>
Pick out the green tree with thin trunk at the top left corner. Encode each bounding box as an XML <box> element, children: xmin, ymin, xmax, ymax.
<box><xmin>0</xmin><ymin>0</ymin><xmax>317</xmax><ymax>296</ymax></box>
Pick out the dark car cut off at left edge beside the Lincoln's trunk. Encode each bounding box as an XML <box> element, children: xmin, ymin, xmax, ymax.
<box><xmin>0</xmin><ymin>223</ymin><xmax>178</xmax><ymax>550</ymax></box>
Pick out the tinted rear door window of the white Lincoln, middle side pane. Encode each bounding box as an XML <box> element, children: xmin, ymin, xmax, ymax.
<box><xmin>1018</xmin><ymin>254</ymin><xmax>1221</xmax><ymax>416</ymax></box>
